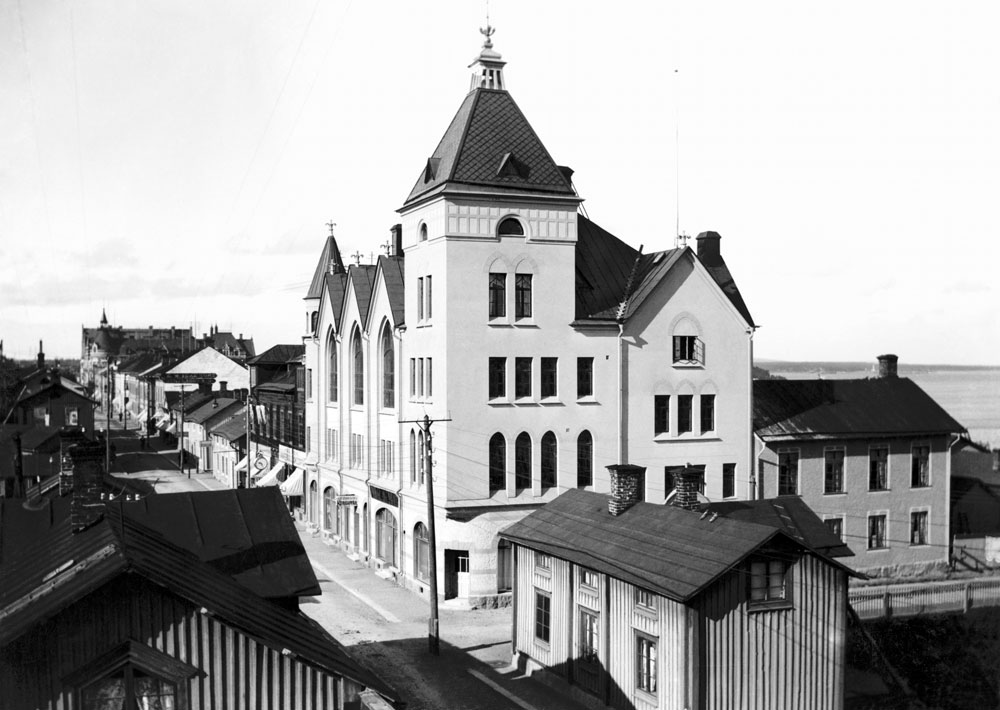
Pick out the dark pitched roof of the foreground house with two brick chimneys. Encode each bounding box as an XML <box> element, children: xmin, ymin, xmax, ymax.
<box><xmin>500</xmin><ymin>490</ymin><xmax>840</xmax><ymax>602</ymax></box>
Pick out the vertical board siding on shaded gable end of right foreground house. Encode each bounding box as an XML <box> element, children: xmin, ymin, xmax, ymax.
<box><xmin>699</xmin><ymin>555</ymin><xmax>847</xmax><ymax>710</ymax></box>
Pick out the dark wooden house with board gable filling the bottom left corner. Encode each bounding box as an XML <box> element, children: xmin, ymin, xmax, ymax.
<box><xmin>0</xmin><ymin>447</ymin><xmax>398</xmax><ymax>710</ymax></box>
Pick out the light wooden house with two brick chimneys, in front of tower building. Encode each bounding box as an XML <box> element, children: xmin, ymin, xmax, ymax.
<box><xmin>501</xmin><ymin>466</ymin><xmax>852</xmax><ymax>710</ymax></box>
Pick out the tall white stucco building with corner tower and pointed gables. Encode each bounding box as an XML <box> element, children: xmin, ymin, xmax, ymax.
<box><xmin>305</xmin><ymin>30</ymin><xmax>754</xmax><ymax>603</ymax></box>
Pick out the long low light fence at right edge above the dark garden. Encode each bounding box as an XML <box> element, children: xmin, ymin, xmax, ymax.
<box><xmin>848</xmin><ymin>577</ymin><xmax>1000</xmax><ymax>619</ymax></box>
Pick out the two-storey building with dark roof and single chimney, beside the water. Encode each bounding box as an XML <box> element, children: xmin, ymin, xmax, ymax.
<box><xmin>754</xmin><ymin>355</ymin><xmax>965</xmax><ymax>576</ymax></box>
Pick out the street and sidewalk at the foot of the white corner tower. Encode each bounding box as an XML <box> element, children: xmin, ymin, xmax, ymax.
<box><xmin>296</xmin><ymin>522</ymin><xmax>583</xmax><ymax>710</ymax></box>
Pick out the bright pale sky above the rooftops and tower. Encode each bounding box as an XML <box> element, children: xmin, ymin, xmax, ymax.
<box><xmin>0</xmin><ymin>0</ymin><xmax>1000</xmax><ymax>365</ymax></box>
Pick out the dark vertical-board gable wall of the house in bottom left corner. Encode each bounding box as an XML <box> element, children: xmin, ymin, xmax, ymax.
<box><xmin>0</xmin><ymin>575</ymin><xmax>361</xmax><ymax>710</ymax></box>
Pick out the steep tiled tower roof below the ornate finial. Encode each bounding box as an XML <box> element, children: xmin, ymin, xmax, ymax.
<box><xmin>406</xmin><ymin>88</ymin><xmax>576</xmax><ymax>203</ymax></box>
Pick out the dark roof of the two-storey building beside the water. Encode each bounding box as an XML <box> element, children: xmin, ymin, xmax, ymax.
<box><xmin>753</xmin><ymin>377</ymin><xmax>965</xmax><ymax>440</ymax></box>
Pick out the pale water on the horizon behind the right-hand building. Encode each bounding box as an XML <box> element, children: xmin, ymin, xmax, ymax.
<box><xmin>772</xmin><ymin>367</ymin><xmax>1000</xmax><ymax>448</ymax></box>
